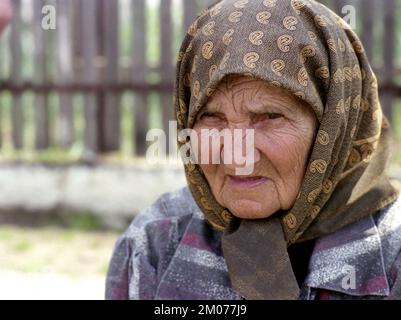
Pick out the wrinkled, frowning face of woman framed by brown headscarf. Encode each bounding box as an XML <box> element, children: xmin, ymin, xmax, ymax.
<box><xmin>194</xmin><ymin>76</ymin><xmax>317</xmax><ymax>219</ymax></box>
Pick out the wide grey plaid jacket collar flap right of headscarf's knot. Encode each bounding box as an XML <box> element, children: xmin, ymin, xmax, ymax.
<box><xmin>304</xmin><ymin>212</ymin><xmax>390</xmax><ymax>296</ymax></box>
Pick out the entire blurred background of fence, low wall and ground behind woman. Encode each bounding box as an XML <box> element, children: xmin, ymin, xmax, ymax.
<box><xmin>0</xmin><ymin>0</ymin><xmax>401</xmax><ymax>299</ymax></box>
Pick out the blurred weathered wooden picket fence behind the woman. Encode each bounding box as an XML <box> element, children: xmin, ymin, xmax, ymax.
<box><xmin>0</xmin><ymin>0</ymin><xmax>401</xmax><ymax>160</ymax></box>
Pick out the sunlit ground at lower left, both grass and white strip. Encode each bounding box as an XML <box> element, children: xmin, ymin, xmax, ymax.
<box><xmin>0</xmin><ymin>226</ymin><xmax>119</xmax><ymax>300</ymax></box>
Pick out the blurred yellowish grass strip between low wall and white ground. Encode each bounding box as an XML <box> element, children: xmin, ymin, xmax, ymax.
<box><xmin>0</xmin><ymin>225</ymin><xmax>120</xmax><ymax>277</ymax></box>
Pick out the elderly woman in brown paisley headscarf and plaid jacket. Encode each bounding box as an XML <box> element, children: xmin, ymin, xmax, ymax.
<box><xmin>106</xmin><ymin>0</ymin><xmax>401</xmax><ymax>299</ymax></box>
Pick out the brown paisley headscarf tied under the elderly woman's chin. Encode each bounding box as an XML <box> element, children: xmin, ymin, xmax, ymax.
<box><xmin>174</xmin><ymin>0</ymin><xmax>398</xmax><ymax>299</ymax></box>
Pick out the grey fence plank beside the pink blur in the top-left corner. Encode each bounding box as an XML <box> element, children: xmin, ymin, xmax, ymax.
<box><xmin>10</xmin><ymin>0</ymin><xmax>24</xmax><ymax>150</ymax></box>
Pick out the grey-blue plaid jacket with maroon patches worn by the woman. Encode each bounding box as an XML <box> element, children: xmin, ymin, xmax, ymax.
<box><xmin>106</xmin><ymin>188</ymin><xmax>401</xmax><ymax>300</ymax></box>
